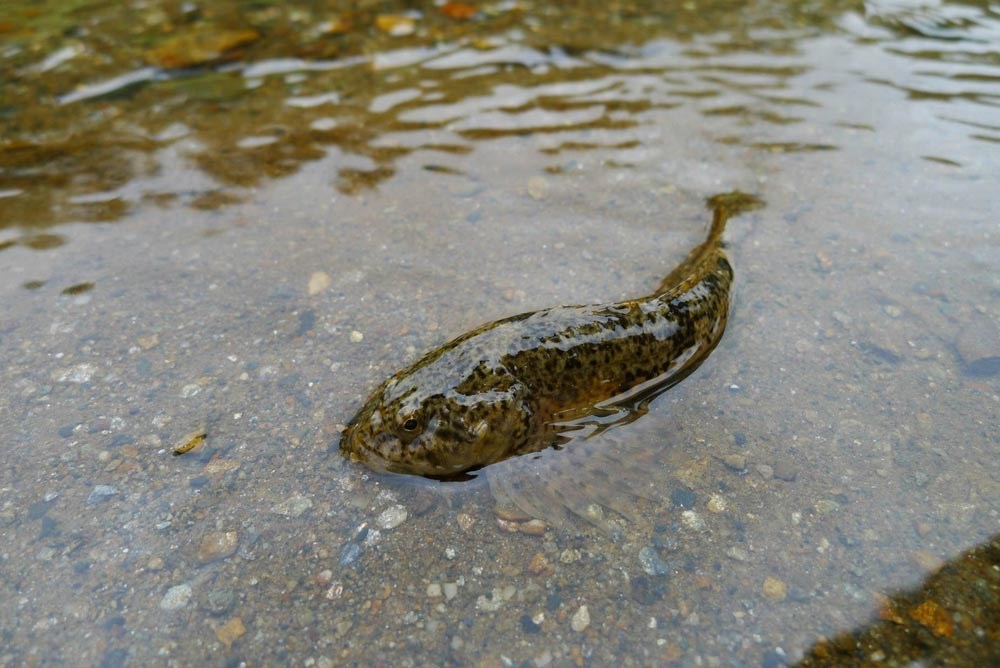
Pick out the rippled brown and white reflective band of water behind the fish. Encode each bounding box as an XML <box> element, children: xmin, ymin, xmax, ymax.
<box><xmin>0</xmin><ymin>2</ymin><xmax>1000</xmax><ymax>240</ymax></box>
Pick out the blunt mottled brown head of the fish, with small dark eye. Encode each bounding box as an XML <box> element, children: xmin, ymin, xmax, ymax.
<box><xmin>340</xmin><ymin>377</ymin><xmax>531</xmax><ymax>479</ymax></box>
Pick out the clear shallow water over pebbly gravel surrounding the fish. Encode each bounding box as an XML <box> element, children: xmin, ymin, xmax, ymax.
<box><xmin>0</xmin><ymin>1</ymin><xmax>1000</xmax><ymax>666</ymax></box>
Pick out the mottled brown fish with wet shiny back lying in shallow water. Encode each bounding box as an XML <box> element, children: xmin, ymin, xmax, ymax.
<box><xmin>340</xmin><ymin>192</ymin><xmax>760</xmax><ymax>479</ymax></box>
